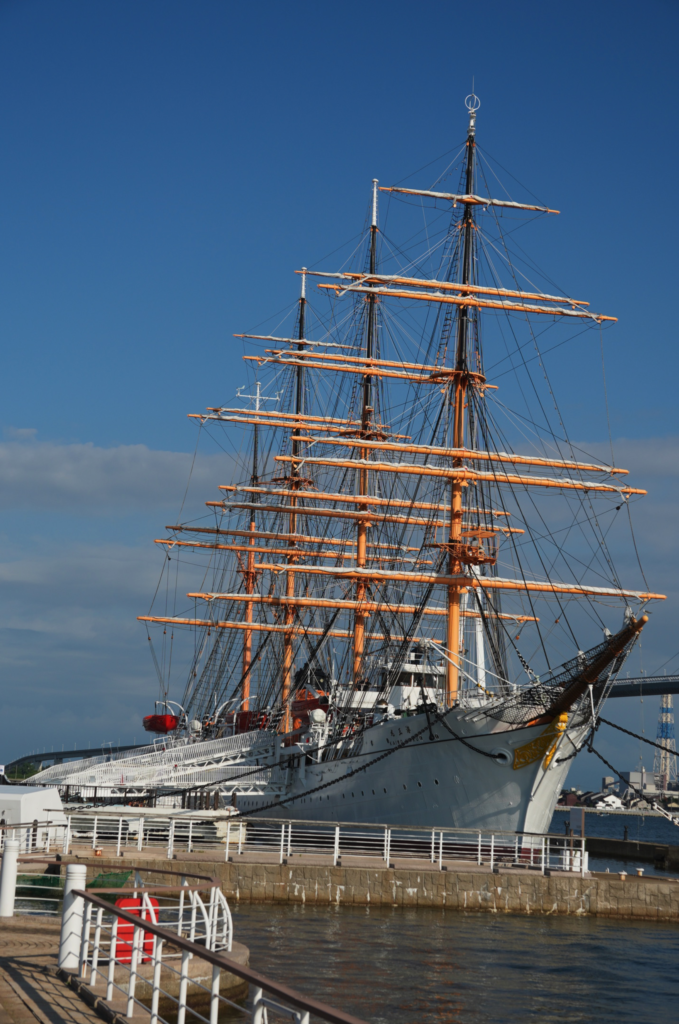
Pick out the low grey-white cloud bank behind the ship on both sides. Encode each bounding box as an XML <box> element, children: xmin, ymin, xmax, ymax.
<box><xmin>0</xmin><ymin>428</ymin><xmax>679</xmax><ymax>781</ymax></box>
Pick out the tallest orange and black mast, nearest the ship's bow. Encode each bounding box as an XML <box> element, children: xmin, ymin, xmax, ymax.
<box><xmin>445</xmin><ymin>96</ymin><xmax>478</xmax><ymax>708</ymax></box>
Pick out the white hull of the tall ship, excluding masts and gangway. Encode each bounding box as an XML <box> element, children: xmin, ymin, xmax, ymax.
<box><xmin>237</xmin><ymin>712</ymin><xmax>581</xmax><ymax>833</ymax></box>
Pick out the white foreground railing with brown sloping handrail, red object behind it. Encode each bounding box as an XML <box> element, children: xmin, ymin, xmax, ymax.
<box><xmin>58</xmin><ymin>865</ymin><xmax>363</xmax><ymax>1024</ymax></box>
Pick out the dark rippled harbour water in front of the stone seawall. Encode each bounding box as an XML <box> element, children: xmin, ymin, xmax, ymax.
<box><xmin>234</xmin><ymin>903</ymin><xmax>679</xmax><ymax>1024</ymax></box>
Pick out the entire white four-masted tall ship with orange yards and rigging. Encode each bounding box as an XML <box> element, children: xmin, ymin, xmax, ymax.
<box><xmin>35</xmin><ymin>94</ymin><xmax>663</xmax><ymax>833</ymax></box>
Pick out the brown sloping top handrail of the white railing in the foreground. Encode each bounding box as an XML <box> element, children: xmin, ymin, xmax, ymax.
<box><xmin>72</xmin><ymin>889</ymin><xmax>365</xmax><ymax>1024</ymax></box>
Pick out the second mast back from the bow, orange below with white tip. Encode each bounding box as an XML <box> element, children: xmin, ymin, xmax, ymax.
<box><xmin>352</xmin><ymin>178</ymin><xmax>378</xmax><ymax>685</ymax></box>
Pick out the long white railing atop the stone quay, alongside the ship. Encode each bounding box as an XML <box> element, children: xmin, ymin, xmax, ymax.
<box><xmin>59</xmin><ymin>808</ymin><xmax>588</xmax><ymax>873</ymax></box>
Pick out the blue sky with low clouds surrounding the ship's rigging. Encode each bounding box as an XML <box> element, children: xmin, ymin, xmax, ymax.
<box><xmin>0</xmin><ymin>0</ymin><xmax>679</xmax><ymax>784</ymax></box>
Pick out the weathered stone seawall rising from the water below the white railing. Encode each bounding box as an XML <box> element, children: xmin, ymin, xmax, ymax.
<box><xmin>69</xmin><ymin>857</ymin><xmax>679</xmax><ymax>922</ymax></box>
